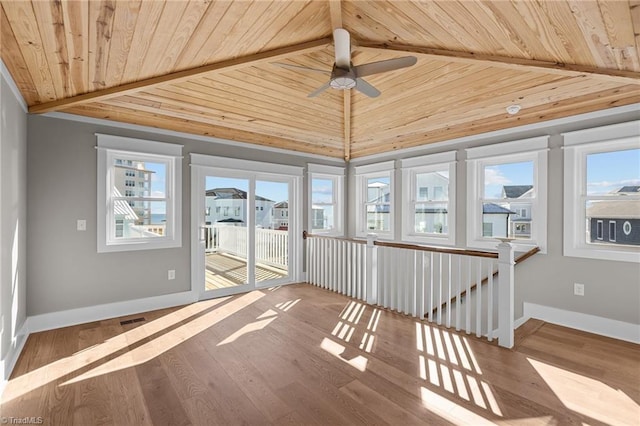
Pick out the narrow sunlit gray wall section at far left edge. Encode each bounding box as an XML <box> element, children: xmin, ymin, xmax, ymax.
<box><xmin>0</xmin><ymin>73</ymin><xmax>27</xmax><ymax>381</ymax></box>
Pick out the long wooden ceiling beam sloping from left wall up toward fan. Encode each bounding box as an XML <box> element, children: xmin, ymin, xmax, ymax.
<box><xmin>29</xmin><ymin>37</ymin><xmax>332</xmax><ymax>114</ymax></box>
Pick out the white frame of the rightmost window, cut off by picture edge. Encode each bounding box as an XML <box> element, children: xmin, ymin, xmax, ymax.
<box><xmin>562</xmin><ymin>120</ymin><xmax>640</xmax><ymax>263</ymax></box>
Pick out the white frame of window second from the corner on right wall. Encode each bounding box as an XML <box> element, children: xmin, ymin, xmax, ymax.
<box><xmin>400</xmin><ymin>151</ymin><xmax>456</xmax><ymax>246</ymax></box>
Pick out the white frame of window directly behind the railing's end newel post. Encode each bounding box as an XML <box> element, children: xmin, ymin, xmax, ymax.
<box><xmin>466</xmin><ymin>136</ymin><xmax>549</xmax><ymax>253</ymax></box>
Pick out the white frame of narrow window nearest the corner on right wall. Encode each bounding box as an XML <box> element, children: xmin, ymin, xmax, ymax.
<box><xmin>355</xmin><ymin>161</ymin><xmax>395</xmax><ymax>240</ymax></box>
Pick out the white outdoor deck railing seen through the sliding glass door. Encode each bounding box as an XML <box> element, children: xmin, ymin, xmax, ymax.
<box><xmin>204</xmin><ymin>225</ymin><xmax>289</xmax><ymax>269</ymax></box>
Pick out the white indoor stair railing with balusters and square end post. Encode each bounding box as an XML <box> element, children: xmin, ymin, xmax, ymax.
<box><xmin>306</xmin><ymin>236</ymin><xmax>514</xmax><ymax>348</ymax></box>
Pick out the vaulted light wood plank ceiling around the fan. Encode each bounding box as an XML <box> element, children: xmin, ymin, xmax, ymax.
<box><xmin>0</xmin><ymin>0</ymin><xmax>640</xmax><ymax>160</ymax></box>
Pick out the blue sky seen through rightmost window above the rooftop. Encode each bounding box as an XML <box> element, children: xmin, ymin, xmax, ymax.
<box><xmin>587</xmin><ymin>149</ymin><xmax>640</xmax><ymax>196</ymax></box>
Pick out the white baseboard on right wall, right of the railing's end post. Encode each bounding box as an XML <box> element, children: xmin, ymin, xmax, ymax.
<box><xmin>523</xmin><ymin>302</ymin><xmax>640</xmax><ymax>343</ymax></box>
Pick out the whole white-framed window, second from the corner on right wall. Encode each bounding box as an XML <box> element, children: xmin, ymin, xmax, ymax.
<box><xmin>400</xmin><ymin>151</ymin><xmax>456</xmax><ymax>245</ymax></box>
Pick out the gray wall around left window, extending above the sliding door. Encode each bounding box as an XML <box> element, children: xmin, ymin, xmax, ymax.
<box><xmin>27</xmin><ymin>115</ymin><xmax>340</xmax><ymax>316</ymax></box>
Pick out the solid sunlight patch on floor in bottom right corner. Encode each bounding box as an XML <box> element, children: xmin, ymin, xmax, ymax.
<box><xmin>527</xmin><ymin>358</ymin><xmax>640</xmax><ymax>425</ymax></box>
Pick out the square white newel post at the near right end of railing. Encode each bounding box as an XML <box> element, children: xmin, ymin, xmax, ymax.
<box><xmin>498</xmin><ymin>241</ymin><xmax>515</xmax><ymax>348</ymax></box>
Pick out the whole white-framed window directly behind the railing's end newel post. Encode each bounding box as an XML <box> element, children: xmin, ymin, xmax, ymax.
<box><xmin>466</xmin><ymin>136</ymin><xmax>549</xmax><ymax>252</ymax></box>
